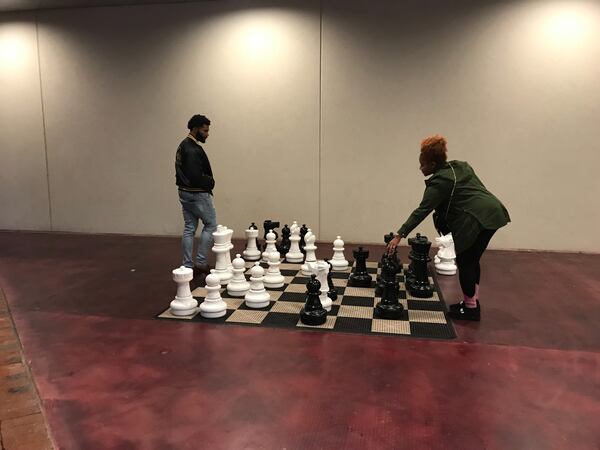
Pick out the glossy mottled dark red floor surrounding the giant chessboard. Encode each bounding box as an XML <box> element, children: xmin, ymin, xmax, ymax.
<box><xmin>0</xmin><ymin>232</ymin><xmax>600</xmax><ymax>450</ymax></box>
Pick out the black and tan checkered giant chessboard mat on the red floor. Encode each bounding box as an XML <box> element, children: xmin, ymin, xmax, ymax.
<box><xmin>157</xmin><ymin>262</ymin><xmax>456</xmax><ymax>339</ymax></box>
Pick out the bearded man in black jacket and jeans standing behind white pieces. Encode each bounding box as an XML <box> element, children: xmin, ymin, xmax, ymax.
<box><xmin>175</xmin><ymin>114</ymin><xmax>217</xmax><ymax>275</ymax></box>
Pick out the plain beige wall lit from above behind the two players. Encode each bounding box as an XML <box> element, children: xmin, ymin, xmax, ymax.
<box><xmin>0</xmin><ymin>0</ymin><xmax>600</xmax><ymax>252</ymax></box>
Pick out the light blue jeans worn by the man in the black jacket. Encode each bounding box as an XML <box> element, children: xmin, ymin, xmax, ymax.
<box><xmin>179</xmin><ymin>191</ymin><xmax>217</xmax><ymax>267</ymax></box>
